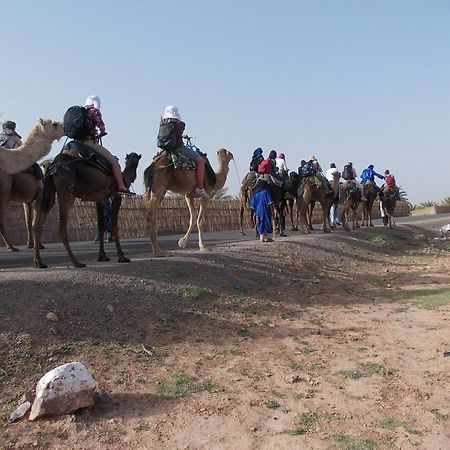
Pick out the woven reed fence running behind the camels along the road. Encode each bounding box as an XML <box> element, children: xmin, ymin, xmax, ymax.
<box><xmin>1</xmin><ymin>197</ymin><xmax>409</xmax><ymax>245</ymax></box>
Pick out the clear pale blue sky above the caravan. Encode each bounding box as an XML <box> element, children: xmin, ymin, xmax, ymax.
<box><xmin>0</xmin><ymin>0</ymin><xmax>450</xmax><ymax>204</ymax></box>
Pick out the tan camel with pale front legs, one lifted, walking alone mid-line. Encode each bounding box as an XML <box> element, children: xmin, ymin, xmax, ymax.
<box><xmin>144</xmin><ymin>148</ymin><xmax>233</xmax><ymax>257</ymax></box>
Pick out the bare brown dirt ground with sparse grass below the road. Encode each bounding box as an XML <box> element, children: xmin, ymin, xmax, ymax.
<box><xmin>0</xmin><ymin>226</ymin><xmax>450</xmax><ymax>450</ymax></box>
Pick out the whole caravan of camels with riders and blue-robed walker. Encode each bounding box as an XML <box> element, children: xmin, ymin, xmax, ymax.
<box><xmin>0</xmin><ymin>99</ymin><xmax>399</xmax><ymax>268</ymax></box>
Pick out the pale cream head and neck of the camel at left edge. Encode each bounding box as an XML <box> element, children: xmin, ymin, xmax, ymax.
<box><xmin>0</xmin><ymin>119</ymin><xmax>64</xmax><ymax>175</ymax></box>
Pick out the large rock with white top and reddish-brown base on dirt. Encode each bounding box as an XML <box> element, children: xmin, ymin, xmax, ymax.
<box><xmin>30</xmin><ymin>362</ymin><xmax>97</xmax><ymax>420</ymax></box>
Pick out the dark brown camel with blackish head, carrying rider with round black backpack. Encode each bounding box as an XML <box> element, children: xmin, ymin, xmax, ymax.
<box><xmin>33</xmin><ymin>153</ymin><xmax>141</xmax><ymax>269</ymax></box>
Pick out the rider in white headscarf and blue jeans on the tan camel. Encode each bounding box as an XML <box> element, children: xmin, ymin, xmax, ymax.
<box><xmin>160</xmin><ymin>105</ymin><xmax>209</xmax><ymax>198</ymax></box>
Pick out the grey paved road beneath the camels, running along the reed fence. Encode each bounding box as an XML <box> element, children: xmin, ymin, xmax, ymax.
<box><xmin>0</xmin><ymin>214</ymin><xmax>450</xmax><ymax>270</ymax></box>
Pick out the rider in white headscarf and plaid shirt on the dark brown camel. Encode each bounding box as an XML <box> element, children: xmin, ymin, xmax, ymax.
<box><xmin>81</xmin><ymin>95</ymin><xmax>135</xmax><ymax>196</ymax></box>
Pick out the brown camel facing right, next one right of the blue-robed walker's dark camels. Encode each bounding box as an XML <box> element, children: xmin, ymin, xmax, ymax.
<box><xmin>300</xmin><ymin>172</ymin><xmax>341</xmax><ymax>233</ymax></box>
